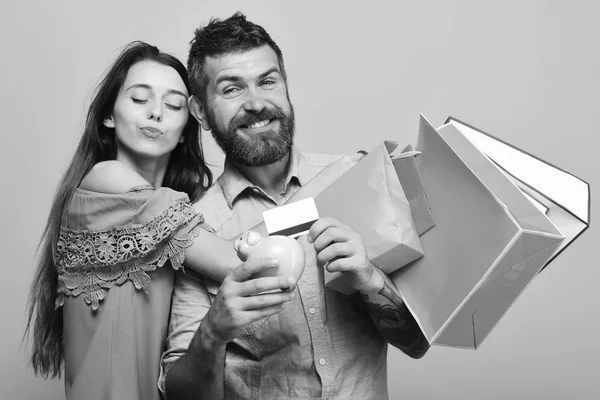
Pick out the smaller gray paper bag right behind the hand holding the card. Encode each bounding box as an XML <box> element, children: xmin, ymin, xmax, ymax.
<box><xmin>315</xmin><ymin>142</ymin><xmax>423</xmax><ymax>293</ymax></box>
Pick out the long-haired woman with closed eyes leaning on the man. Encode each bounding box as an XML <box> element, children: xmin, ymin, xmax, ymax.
<box><xmin>27</xmin><ymin>42</ymin><xmax>248</xmax><ymax>399</ymax></box>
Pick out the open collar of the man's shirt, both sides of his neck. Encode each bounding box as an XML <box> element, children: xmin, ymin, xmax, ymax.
<box><xmin>217</xmin><ymin>146</ymin><xmax>310</xmax><ymax>208</ymax></box>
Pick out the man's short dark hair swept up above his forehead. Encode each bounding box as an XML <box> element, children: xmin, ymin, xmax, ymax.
<box><xmin>187</xmin><ymin>11</ymin><xmax>287</xmax><ymax>101</ymax></box>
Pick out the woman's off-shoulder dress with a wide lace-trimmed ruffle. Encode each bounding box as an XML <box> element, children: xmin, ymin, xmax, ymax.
<box><xmin>55</xmin><ymin>186</ymin><xmax>204</xmax><ymax>400</ymax></box>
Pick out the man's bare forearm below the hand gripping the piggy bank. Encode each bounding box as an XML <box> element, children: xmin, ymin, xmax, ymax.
<box><xmin>165</xmin><ymin>318</ymin><xmax>226</xmax><ymax>400</ymax></box>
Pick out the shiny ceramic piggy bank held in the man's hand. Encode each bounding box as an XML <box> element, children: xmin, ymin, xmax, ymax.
<box><xmin>234</xmin><ymin>231</ymin><xmax>304</xmax><ymax>282</ymax></box>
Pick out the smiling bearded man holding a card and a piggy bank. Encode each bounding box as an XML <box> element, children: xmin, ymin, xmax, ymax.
<box><xmin>159</xmin><ymin>13</ymin><xmax>429</xmax><ymax>399</ymax></box>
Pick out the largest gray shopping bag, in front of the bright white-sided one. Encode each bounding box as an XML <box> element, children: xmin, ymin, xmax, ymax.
<box><xmin>391</xmin><ymin>117</ymin><xmax>589</xmax><ymax>348</ymax></box>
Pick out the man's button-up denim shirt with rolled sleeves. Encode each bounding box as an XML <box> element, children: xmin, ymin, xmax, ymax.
<box><xmin>159</xmin><ymin>148</ymin><xmax>388</xmax><ymax>400</ymax></box>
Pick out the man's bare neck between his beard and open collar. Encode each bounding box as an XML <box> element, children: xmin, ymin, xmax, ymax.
<box><xmin>234</xmin><ymin>152</ymin><xmax>291</xmax><ymax>199</ymax></box>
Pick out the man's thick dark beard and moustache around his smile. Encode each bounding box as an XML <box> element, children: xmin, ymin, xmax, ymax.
<box><xmin>204</xmin><ymin>104</ymin><xmax>295</xmax><ymax>167</ymax></box>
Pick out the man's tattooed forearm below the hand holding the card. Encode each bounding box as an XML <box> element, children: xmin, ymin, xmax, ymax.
<box><xmin>361</xmin><ymin>269</ymin><xmax>429</xmax><ymax>358</ymax></box>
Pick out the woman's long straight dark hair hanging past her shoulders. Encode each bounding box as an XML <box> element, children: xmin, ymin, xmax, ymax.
<box><xmin>25</xmin><ymin>42</ymin><xmax>212</xmax><ymax>378</ymax></box>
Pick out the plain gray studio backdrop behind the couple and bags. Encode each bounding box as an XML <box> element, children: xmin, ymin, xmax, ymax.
<box><xmin>0</xmin><ymin>0</ymin><xmax>600</xmax><ymax>400</ymax></box>
